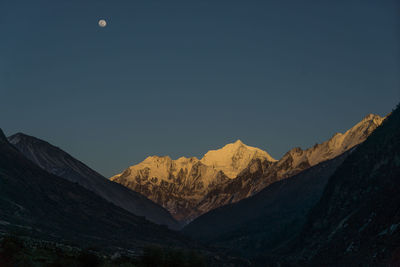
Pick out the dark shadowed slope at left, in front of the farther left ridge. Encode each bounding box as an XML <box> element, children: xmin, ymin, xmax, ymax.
<box><xmin>0</xmin><ymin>130</ymin><xmax>190</xmax><ymax>250</ymax></box>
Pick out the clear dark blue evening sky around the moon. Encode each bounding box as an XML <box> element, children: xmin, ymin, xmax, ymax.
<box><xmin>0</xmin><ymin>0</ymin><xmax>400</xmax><ymax>176</ymax></box>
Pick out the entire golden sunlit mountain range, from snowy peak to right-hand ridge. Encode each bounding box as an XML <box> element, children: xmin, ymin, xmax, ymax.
<box><xmin>111</xmin><ymin>114</ymin><xmax>383</xmax><ymax>222</ymax></box>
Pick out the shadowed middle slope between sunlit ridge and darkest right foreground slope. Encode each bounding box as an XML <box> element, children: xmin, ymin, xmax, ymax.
<box><xmin>183</xmin><ymin>151</ymin><xmax>350</xmax><ymax>257</ymax></box>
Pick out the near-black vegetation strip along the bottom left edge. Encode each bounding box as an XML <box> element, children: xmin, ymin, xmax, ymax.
<box><xmin>0</xmin><ymin>235</ymin><xmax>208</xmax><ymax>267</ymax></box>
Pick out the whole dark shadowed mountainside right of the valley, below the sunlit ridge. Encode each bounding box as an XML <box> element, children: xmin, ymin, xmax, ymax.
<box><xmin>183</xmin><ymin>109</ymin><xmax>400</xmax><ymax>266</ymax></box>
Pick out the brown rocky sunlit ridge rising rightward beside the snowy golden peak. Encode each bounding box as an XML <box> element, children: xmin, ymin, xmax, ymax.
<box><xmin>195</xmin><ymin>114</ymin><xmax>384</xmax><ymax>215</ymax></box>
